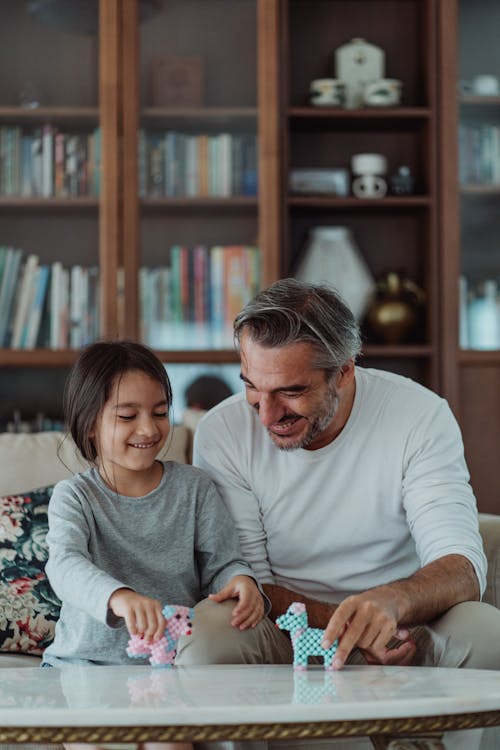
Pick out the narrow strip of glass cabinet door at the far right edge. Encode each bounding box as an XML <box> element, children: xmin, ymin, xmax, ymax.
<box><xmin>458</xmin><ymin>0</ymin><xmax>500</xmax><ymax>350</ymax></box>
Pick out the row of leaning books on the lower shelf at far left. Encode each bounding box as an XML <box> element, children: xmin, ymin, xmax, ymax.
<box><xmin>0</xmin><ymin>246</ymin><xmax>99</xmax><ymax>349</ymax></box>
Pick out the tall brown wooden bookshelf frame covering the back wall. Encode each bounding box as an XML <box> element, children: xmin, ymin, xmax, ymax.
<box><xmin>0</xmin><ymin>0</ymin><xmax>500</xmax><ymax>509</ymax></box>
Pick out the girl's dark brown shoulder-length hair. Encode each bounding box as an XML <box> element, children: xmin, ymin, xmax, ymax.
<box><xmin>63</xmin><ymin>341</ymin><xmax>172</xmax><ymax>462</ymax></box>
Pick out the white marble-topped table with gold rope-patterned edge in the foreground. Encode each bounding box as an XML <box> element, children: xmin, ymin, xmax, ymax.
<box><xmin>0</xmin><ymin>665</ymin><xmax>500</xmax><ymax>743</ymax></box>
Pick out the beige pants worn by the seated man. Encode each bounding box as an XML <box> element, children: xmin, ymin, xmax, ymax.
<box><xmin>176</xmin><ymin>599</ymin><xmax>500</xmax><ymax>669</ymax></box>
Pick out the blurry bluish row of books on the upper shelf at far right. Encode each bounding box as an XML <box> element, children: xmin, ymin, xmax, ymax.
<box><xmin>458</xmin><ymin>124</ymin><xmax>500</xmax><ymax>185</ymax></box>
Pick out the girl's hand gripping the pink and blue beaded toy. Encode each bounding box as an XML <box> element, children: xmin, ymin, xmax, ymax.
<box><xmin>108</xmin><ymin>588</ymin><xmax>167</xmax><ymax>641</ymax></box>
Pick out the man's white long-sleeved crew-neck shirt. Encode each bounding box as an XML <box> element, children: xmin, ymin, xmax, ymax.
<box><xmin>194</xmin><ymin>367</ymin><xmax>486</xmax><ymax>603</ymax></box>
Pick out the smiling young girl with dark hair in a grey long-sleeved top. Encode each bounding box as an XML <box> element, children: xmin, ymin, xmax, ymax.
<box><xmin>43</xmin><ymin>341</ymin><xmax>264</xmax><ymax>750</ymax></box>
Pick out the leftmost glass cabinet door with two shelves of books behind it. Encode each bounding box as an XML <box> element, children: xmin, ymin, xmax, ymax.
<box><xmin>0</xmin><ymin>0</ymin><xmax>102</xmax><ymax>430</ymax></box>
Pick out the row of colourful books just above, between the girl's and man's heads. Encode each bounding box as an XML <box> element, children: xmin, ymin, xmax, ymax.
<box><xmin>139</xmin><ymin>245</ymin><xmax>260</xmax><ymax>349</ymax></box>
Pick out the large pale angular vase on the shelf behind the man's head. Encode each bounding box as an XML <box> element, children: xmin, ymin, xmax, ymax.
<box><xmin>294</xmin><ymin>226</ymin><xmax>375</xmax><ymax>321</ymax></box>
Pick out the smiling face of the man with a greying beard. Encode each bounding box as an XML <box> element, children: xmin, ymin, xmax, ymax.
<box><xmin>240</xmin><ymin>333</ymin><xmax>353</xmax><ymax>450</ymax></box>
